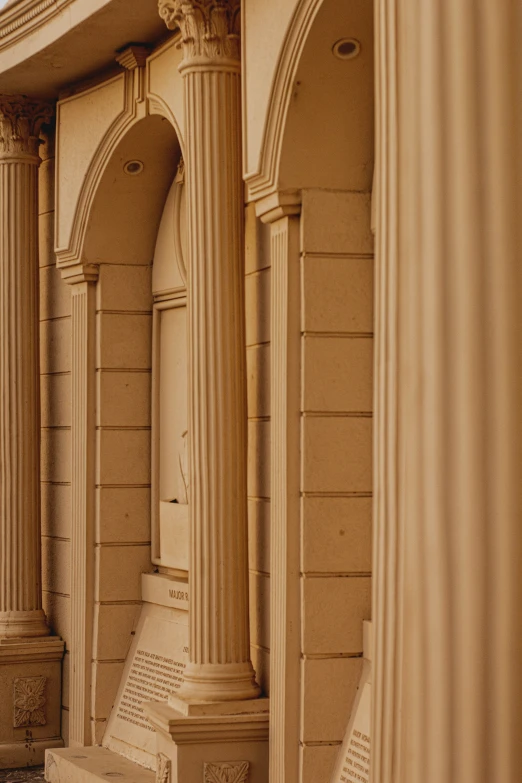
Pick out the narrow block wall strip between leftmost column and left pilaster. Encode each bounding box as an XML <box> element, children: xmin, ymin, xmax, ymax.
<box><xmin>39</xmin><ymin>125</ymin><xmax>71</xmax><ymax>742</ymax></box>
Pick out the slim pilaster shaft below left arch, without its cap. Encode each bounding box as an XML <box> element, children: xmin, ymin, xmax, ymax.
<box><xmin>69</xmin><ymin>281</ymin><xmax>95</xmax><ymax>746</ymax></box>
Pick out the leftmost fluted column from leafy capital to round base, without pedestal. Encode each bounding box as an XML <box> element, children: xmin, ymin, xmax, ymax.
<box><xmin>0</xmin><ymin>95</ymin><xmax>52</xmax><ymax>639</ymax></box>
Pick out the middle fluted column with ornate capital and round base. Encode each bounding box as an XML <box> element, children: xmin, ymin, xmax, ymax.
<box><xmin>159</xmin><ymin>0</ymin><xmax>259</xmax><ymax>701</ymax></box>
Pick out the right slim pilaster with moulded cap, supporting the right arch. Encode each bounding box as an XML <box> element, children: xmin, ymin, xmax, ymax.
<box><xmin>256</xmin><ymin>193</ymin><xmax>301</xmax><ymax>783</ymax></box>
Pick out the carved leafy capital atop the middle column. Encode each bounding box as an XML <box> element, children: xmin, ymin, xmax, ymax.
<box><xmin>158</xmin><ymin>0</ymin><xmax>241</xmax><ymax>60</ymax></box>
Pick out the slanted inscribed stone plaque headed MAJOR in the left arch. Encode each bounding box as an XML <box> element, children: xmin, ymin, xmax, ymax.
<box><xmin>103</xmin><ymin>575</ymin><xmax>188</xmax><ymax>769</ymax></box>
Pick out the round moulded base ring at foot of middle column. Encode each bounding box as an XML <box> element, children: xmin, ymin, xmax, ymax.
<box><xmin>177</xmin><ymin>661</ymin><xmax>261</xmax><ymax>703</ymax></box>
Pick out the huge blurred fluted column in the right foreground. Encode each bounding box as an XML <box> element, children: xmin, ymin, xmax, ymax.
<box><xmin>372</xmin><ymin>0</ymin><xmax>522</xmax><ymax>783</ymax></box>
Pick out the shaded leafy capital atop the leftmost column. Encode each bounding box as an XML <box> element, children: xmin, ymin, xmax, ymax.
<box><xmin>0</xmin><ymin>95</ymin><xmax>53</xmax><ymax>158</ymax></box>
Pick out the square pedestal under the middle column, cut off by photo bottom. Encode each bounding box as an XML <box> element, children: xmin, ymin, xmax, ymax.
<box><xmin>143</xmin><ymin>699</ymin><xmax>269</xmax><ymax>783</ymax></box>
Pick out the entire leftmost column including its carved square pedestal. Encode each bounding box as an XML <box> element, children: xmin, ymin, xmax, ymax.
<box><xmin>0</xmin><ymin>95</ymin><xmax>63</xmax><ymax>766</ymax></box>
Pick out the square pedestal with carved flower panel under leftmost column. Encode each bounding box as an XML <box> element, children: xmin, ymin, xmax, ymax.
<box><xmin>0</xmin><ymin>636</ymin><xmax>64</xmax><ymax>769</ymax></box>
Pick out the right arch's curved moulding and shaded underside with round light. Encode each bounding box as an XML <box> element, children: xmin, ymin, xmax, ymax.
<box><xmin>247</xmin><ymin>0</ymin><xmax>374</xmax><ymax>200</ymax></box>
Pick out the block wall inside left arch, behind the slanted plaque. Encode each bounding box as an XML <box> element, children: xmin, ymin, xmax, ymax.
<box><xmin>91</xmin><ymin>258</ymin><xmax>152</xmax><ymax>743</ymax></box>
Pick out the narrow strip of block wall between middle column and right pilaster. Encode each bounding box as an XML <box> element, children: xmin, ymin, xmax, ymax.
<box><xmin>245</xmin><ymin>204</ymin><xmax>270</xmax><ymax>694</ymax></box>
